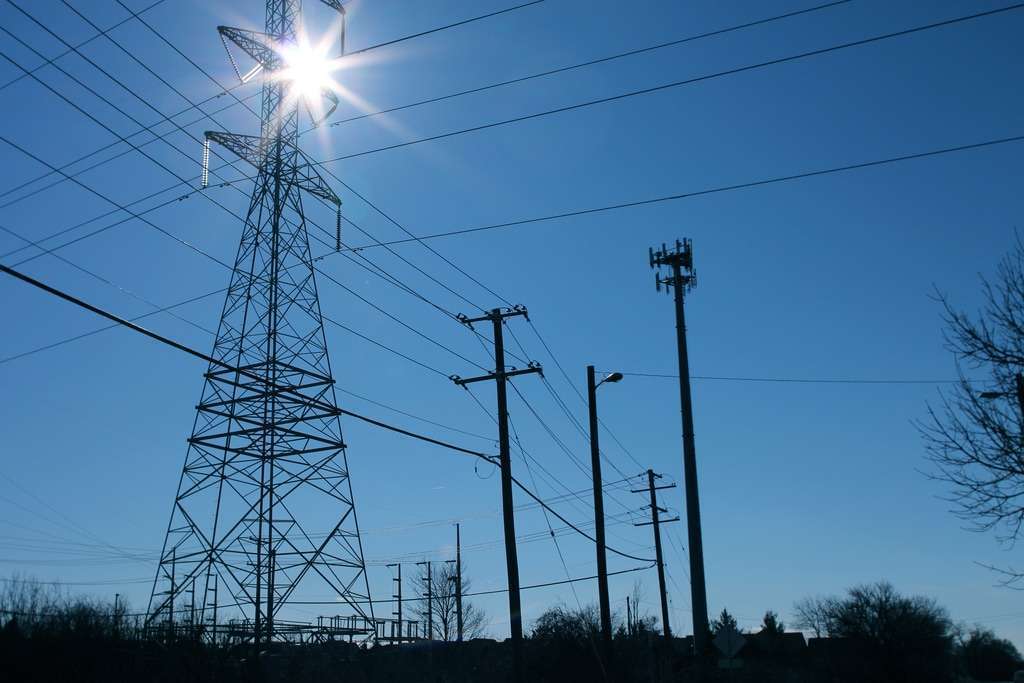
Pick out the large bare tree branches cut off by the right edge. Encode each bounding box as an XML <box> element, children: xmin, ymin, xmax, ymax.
<box><xmin>918</xmin><ymin>239</ymin><xmax>1024</xmax><ymax>584</ymax></box>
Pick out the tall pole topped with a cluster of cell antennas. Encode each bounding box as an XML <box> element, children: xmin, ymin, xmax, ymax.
<box><xmin>648</xmin><ymin>240</ymin><xmax>709</xmax><ymax>656</ymax></box>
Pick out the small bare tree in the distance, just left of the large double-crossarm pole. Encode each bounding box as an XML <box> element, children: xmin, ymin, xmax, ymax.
<box><xmin>412</xmin><ymin>562</ymin><xmax>487</xmax><ymax>641</ymax></box>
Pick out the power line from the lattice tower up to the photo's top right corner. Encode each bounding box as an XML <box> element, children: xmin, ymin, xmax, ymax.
<box><xmin>319</xmin><ymin>3</ymin><xmax>1024</xmax><ymax>168</ymax></box>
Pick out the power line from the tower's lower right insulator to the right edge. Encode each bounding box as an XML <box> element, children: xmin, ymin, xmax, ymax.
<box><xmin>337</xmin><ymin>135</ymin><xmax>1024</xmax><ymax>251</ymax></box>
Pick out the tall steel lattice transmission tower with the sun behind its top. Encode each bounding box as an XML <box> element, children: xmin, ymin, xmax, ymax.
<box><xmin>148</xmin><ymin>0</ymin><xmax>373</xmax><ymax>644</ymax></box>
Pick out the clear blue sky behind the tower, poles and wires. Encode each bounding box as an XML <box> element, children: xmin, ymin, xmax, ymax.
<box><xmin>0</xmin><ymin>0</ymin><xmax>1024</xmax><ymax>644</ymax></box>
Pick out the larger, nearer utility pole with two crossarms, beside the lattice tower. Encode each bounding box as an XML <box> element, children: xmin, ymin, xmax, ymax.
<box><xmin>452</xmin><ymin>306</ymin><xmax>543</xmax><ymax>683</ymax></box>
